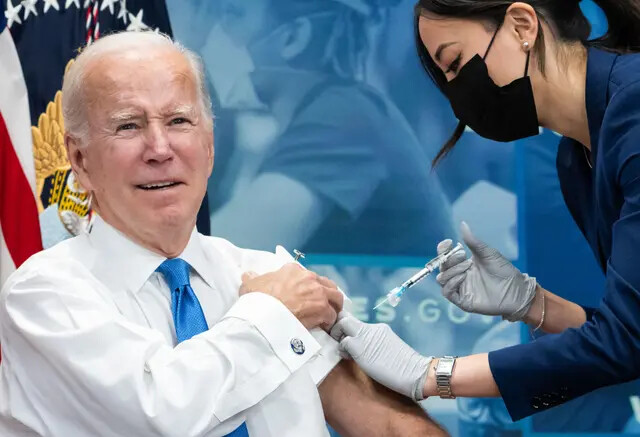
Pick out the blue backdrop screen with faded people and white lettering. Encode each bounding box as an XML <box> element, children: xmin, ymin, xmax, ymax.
<box><xmin>167</xmin><ymin>0</ymin><xmax>640</xmax><ymax>436</ymax></box>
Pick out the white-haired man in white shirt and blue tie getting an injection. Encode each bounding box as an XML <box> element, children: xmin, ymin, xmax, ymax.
<box><xmin>0</xmin><ymin>33</ymin><xmax>442</xmax><ymax>437</ymax></box>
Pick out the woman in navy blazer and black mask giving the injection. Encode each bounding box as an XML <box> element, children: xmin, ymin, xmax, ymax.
<box><xmin>332</xmin><ymin>0</ymin><xmax>640</xmax><ymax>420</ymax></box>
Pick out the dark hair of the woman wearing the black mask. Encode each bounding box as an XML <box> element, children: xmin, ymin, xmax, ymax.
<box><xmin>414</xmin><ymin>0</ymin><xmax>640</xmax><ymax>167</ymax></box>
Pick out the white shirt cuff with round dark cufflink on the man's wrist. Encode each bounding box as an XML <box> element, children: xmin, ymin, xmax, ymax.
<box><xmin>222</xmin><ymin>292</ymin><xmax>321</xmax><ymax>373</ymax></box>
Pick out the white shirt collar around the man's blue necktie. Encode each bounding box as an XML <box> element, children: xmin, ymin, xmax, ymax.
<box><xmin>89</xmin><ymin>216</ymin><xmax>214</xmax><ymax>292</ymax></box>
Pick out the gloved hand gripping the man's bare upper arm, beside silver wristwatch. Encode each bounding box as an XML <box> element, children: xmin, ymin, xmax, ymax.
<box><xmin>331</xmin><ymin>311</ymin><xmax>433</xmax><ymax>401</ymax></box>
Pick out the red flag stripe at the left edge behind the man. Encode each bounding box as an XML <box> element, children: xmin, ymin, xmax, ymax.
<box><xmin>0</xmin><ymin>114</ymin><xmax>42</xmax><ymax>268</ymax></box>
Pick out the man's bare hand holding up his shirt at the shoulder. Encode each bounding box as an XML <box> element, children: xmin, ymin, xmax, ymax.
<box><xmin>240</xmin><ymin>264</ymin><xmax>344</xmax><ymax>331</ymax></box>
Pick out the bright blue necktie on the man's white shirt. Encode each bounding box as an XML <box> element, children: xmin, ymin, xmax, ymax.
<box><xmin>156</xmin><ymin>258</ymin><xmax>249</xmax><ymax>437</ymax></box>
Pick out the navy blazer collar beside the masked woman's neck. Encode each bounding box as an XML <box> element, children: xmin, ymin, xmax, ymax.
<box><xmin>585</xmin><ymin>47</ymin><xmax>618</xmax><ymax>162</ymax></box>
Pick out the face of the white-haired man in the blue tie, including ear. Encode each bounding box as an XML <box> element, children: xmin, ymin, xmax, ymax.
<box><xmin>69</xmin><ymin>48</ymin><xmax>213</xmax><ymax>241</ymax></box>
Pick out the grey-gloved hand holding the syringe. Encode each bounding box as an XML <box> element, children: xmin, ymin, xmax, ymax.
<box><xmin>436</xmin><ymin>222</ymin><xmax>537</xmax><ymax>322</ymax></box>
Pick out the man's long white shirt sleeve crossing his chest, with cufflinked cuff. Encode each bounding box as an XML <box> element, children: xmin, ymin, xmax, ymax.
<box><xmin>0</xmin><ymin>259</ymin><xmax>320</xmax><ymax>437</ymax></box>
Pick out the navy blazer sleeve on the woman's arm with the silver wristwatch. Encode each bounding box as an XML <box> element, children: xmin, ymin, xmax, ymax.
<box><xmin>489</xmin><ymin>82</ymin><xmax>640</xmax><ymax>420</ymax></box>
